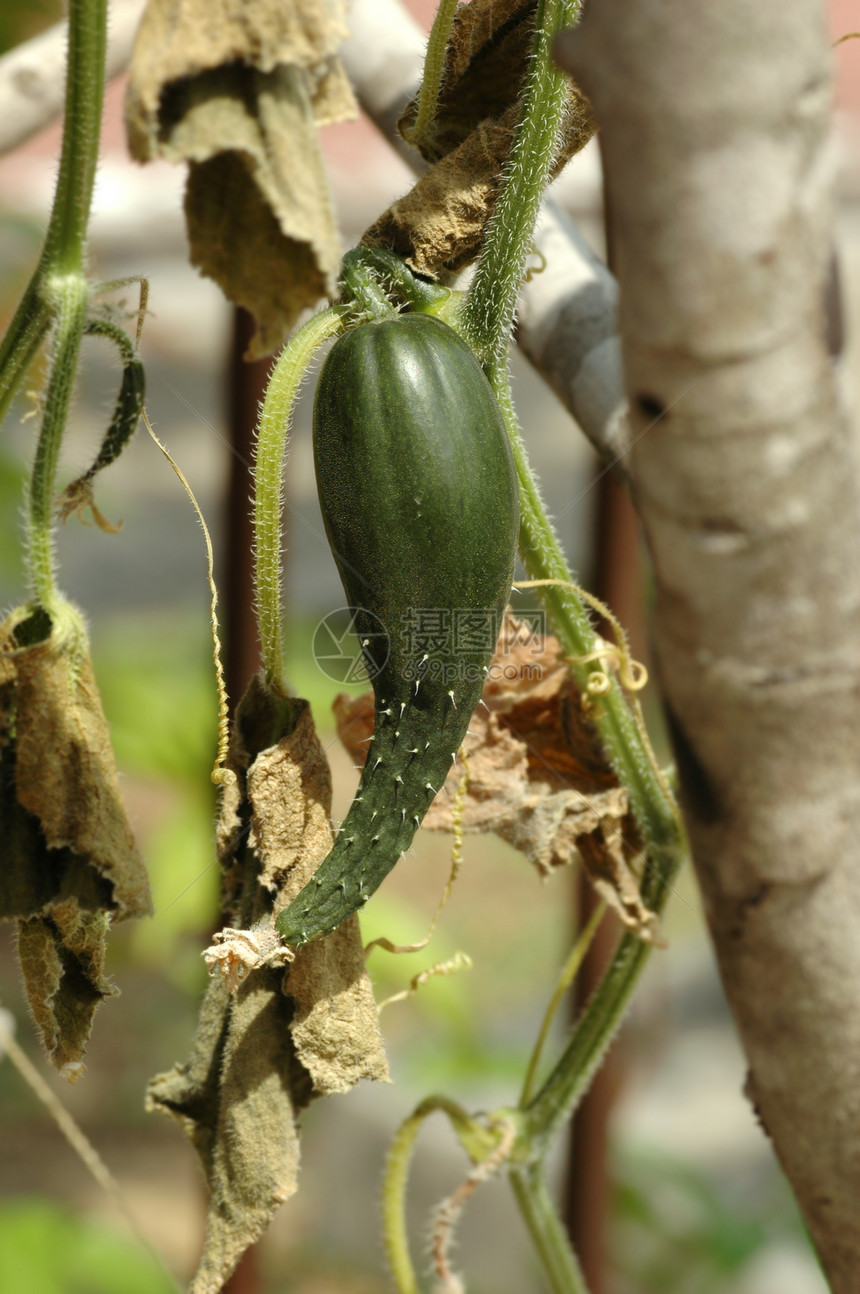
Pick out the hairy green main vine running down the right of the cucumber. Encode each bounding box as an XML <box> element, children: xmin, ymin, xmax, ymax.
<box><xmin>252</xmin><ymin>0</ymin><xmax>685</xmax><ymax>1294</ymax></box>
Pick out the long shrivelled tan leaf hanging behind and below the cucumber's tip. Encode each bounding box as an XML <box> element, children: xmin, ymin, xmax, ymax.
<box><xmin>147</xmin><ymin>681</ymin><xmax>388</xmax><ymax>1294</ymax></box>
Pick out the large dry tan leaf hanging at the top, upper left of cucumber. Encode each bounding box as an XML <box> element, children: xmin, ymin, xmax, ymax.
<box><xmin>125</xmin><ymin>0</ymin><xmax>357</xmax><ymax>358</ymax></box>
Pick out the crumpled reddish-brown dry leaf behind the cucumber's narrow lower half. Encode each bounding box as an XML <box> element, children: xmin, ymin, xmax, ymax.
<box><xmin>334</xmin><ymin>613</ymin><xmax>660</xmax><ymax>942</ymax></box>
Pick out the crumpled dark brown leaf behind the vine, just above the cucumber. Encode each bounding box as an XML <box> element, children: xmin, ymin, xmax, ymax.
<box><xmin>362</xmin><ymin>0</ymin><xmax>595</xmax><ymax>276</ymax></box>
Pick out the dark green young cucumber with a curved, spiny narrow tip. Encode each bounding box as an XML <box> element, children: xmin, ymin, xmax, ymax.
<box><xmin>277</xmin><ymin>307</ymin><xmax>519</xmax><ymax>947</ymax></box>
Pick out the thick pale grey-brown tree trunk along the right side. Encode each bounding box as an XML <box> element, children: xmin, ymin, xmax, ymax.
<box><xmin>560</xmin><ymin>0</ymin><xmax>860</xmax><ymax>1294</ymax></box>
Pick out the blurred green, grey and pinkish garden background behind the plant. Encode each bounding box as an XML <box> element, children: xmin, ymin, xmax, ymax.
<box><xmin>0</xmin><ymin>0</ymin><xmax>860</xmax><ymax>1294</ymax></box>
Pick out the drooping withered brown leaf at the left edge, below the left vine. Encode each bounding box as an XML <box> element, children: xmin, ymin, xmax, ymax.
<box><xmin>0</xmin><ymin>606</ymin><xmax>151</xmax><ymax>1077</ymax></box>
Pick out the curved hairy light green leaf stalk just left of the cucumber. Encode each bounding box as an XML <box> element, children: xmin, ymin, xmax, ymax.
<box><xmin>253</xmin><ymin>305</ymin><xmax>348</xmax><ymax>685</ymax></box>
